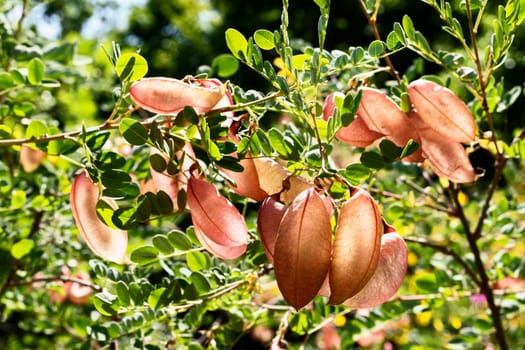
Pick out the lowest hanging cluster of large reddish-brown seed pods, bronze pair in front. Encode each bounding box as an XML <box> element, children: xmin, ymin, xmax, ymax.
<box><xmin>253</xmin><ymin>172</ymin><xmax>407</xmax><ymax>309</ymax></box>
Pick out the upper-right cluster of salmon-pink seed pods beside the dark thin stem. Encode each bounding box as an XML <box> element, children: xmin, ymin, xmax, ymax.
<box><xmin>323</xmin><ymin>79</ymin><xmax>476</xmax><ymax>183</ymax></box>
